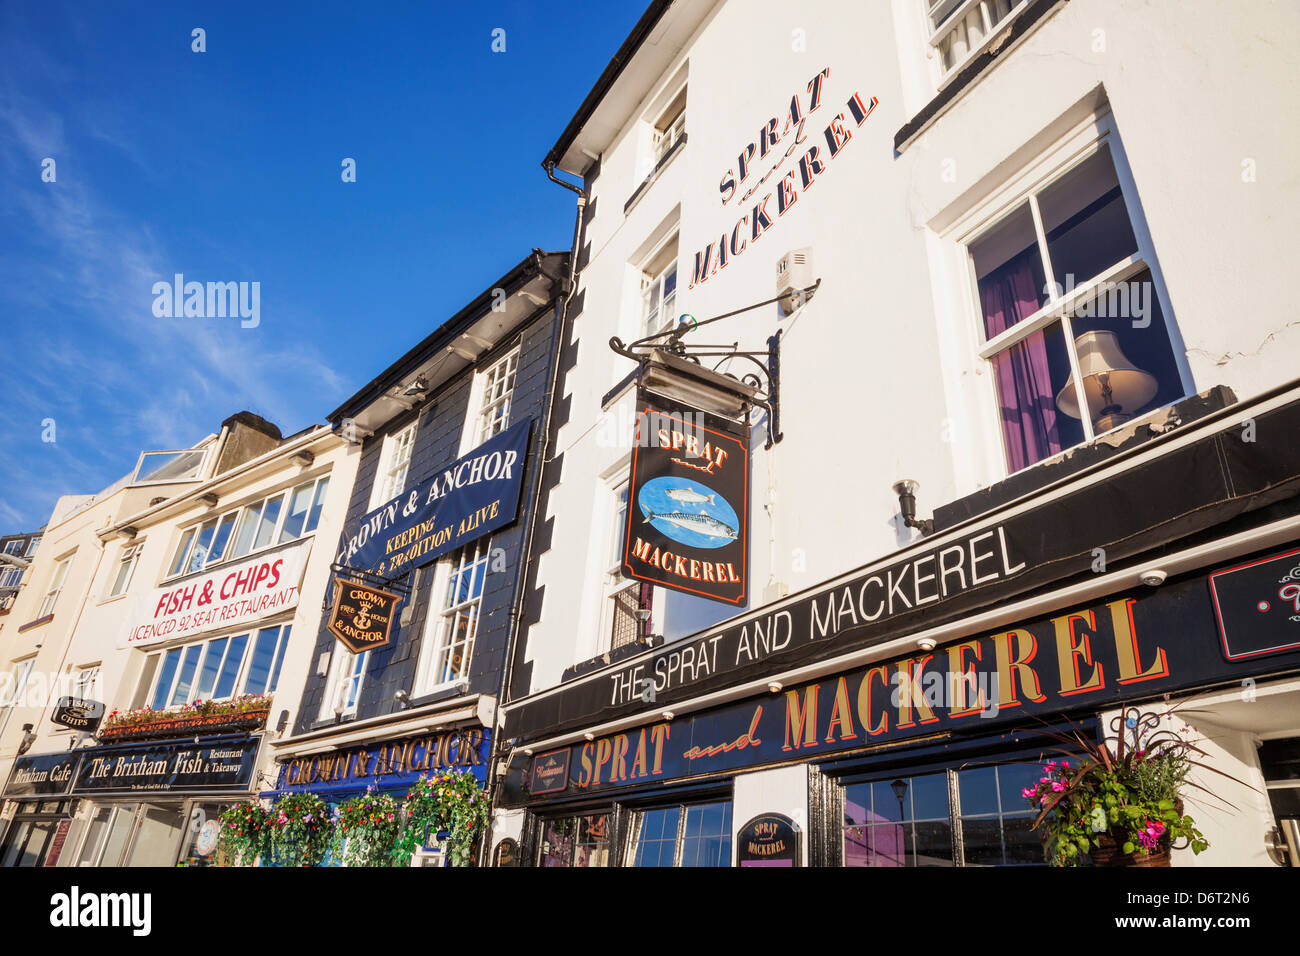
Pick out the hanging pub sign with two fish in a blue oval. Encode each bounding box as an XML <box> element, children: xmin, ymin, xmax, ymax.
<box><xmin>623</xmin><ymin>389</ymin><xmax>749</xmax><ymax>605</ymax></box>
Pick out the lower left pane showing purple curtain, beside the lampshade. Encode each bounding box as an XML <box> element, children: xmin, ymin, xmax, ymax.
<box><xmin>992</xmin><ymin>324</ymin><xmax>1083</xmax><ymax>472</ymax></box>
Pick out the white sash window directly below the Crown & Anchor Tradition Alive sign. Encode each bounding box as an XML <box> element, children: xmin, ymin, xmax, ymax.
<box><xmin>419</xmin><ymin>538</ymin><xmax>490</xmax><ymax>692</ymax></box>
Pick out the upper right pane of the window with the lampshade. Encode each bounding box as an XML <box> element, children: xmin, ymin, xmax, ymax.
<box><xmin>1039</xmin><ymin>146</ymin><xmax>1138</xmax><ymax>287</ymax></box>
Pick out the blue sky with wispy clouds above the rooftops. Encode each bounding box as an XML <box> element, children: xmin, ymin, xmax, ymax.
<box><xmin>0</xmin><ymin>0</ymin><xmax>644</xmax><ymax>532</ymax></box>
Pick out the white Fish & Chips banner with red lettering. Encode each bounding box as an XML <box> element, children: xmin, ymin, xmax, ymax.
<box><xmin>117</xmin><ymin>541</ymin><xmax>311</xmax><ymax>648</ymax></box>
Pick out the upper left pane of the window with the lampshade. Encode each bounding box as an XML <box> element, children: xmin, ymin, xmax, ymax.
<box><xmin>970</xmin><ymin>204</ymin><xmax>1047</xmax><ymax>338</ymax></box>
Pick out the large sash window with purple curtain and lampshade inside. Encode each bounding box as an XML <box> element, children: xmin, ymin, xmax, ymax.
<box><xmin>967</xmin><ymin>139</ymin><xmax>1186</xmax><ymax>472</ymax></box>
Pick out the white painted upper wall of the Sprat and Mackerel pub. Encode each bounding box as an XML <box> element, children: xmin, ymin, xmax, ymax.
<box><xmin>527</xmin><ymin>0</ymin><xmax>1300</xmax><ymax>691</ymax></box>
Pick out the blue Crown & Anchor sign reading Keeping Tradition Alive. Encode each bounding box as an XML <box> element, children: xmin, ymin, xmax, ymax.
<box><xmin>338</xmin><ymin>419</ymin><xmax>533</xmax><ymax>579</ymax></box>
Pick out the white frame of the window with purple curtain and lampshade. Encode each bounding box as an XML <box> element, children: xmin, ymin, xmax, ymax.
<box><xmin>944</xmin><ymin>109</ymin><xmax>1195</xmax><ymax>481</ymax></box>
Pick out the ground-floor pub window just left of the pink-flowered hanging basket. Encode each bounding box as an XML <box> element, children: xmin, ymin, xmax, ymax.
<box><xmin>841</xmin><ymin>763</ymin><xmax>1043</xmax><ymax>866</ymax></box>
